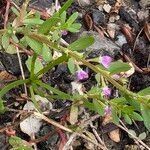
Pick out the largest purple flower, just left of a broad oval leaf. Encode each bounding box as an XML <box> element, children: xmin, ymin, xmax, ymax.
<box><xmin>100</xmin><ymin>55</ymin><xmax>112</xmax><ymax>68</ymax></box>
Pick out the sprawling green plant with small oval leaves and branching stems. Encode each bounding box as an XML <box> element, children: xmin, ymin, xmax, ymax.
<box><xmin>0</xmin><ymin>0</ymin><xmax>150</xmax><ymax>131</ymax></box>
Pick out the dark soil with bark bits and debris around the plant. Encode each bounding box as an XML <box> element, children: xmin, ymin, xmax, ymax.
<box><xmin>0</xmin><ymin>0</ymin><xmax>150</xmax><ymax>150</ymax></box>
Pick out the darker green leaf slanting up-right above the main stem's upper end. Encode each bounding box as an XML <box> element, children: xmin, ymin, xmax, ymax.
<box><xmin>38</xmin><ymin>17</ymin><xmax>60</xmax><ymax>34</ymax></box>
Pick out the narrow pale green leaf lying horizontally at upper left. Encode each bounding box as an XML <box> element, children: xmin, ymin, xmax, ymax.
<box><xmin>23</xmin><ymin>18</ymin><xmax>44</xmax><ymax>25</ymax></box>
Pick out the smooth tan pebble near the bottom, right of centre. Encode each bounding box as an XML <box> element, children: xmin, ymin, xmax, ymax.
<box><xmin>109</xmin><ymin>129</ymin><xmax>120</xmax><ymax>143</ymax></box>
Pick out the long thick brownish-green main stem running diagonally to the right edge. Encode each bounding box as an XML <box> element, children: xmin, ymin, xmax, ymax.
<box><xmin>20</xmin><ymin>33</ymin><xmax>150</xmax><ymax>107</ymax></box>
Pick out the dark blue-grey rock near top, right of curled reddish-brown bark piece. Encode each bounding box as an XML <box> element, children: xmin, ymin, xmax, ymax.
<box><xmin>92</xmin><ymin>9</ymin><xmax>105</xmax><ymax>25</ymax></box>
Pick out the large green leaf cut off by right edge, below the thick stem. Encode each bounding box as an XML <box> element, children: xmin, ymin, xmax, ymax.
<box><xmin>141</xmin><ymin>104</ymin><xmax>150</xmax><ymax>131</ymax></box>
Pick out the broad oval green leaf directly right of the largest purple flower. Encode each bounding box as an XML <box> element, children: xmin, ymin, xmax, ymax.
<box><xmin>108</xmin><ymin>61</ymin><xmax>131</xmax><ymax>74</ymax></box>
